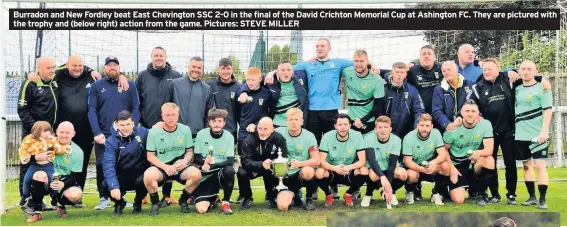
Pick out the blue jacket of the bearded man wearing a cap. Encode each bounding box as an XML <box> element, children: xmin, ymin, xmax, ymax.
<box><xmin>88</xmin><ymin>78</ymin><xmax>140</xmax><ymax>137</ymax></box>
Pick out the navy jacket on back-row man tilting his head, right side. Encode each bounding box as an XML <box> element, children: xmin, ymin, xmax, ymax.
<box><xmin>432</xmin><ymin>74</ymin><xmax>473</xmax><ymax>133</ymax></box>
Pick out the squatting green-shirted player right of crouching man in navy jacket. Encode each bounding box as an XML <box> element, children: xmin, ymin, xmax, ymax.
<box><xmin>144</xmin><ymin>103</ymin><xmax>201</xmax><ymax>215</ymax></box>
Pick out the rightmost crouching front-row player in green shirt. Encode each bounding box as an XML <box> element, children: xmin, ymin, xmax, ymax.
<box><xmin>443</xmin><ymin>100</ymin><xmax>498</xmax><ymax>206</ymax></box>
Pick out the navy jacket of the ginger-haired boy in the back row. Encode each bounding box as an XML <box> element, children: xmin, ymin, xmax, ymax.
<box><xmin>234</xmin><ymin>83</ymin><xmax>273</xmax><ymax>140</ymax></box>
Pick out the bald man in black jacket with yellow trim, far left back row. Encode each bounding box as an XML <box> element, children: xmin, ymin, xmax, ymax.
<box><xmin>18</xmin><ymin>57</ymin><xmax>59</xmax><ymax>206</ymax></box>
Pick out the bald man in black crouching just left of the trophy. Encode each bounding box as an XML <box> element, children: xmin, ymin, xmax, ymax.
<box><xmin>238</xmin><ymin>117</ymin><xmax>287</xmax><ymax>209</ymax></box>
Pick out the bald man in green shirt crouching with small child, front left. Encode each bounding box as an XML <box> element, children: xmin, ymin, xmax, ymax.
<box><xmin>27</xmin><ymin>121</ymin><xmax>83</xmax><ymax>223</ymax></box>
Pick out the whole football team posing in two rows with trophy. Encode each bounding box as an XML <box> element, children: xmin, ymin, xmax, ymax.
<box><xmin>18</xmin><ymin>38</ymin><xmax>553</xmax><ymax>223</ymax></box>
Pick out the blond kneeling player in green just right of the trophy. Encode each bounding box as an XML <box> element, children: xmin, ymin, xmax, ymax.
<box><xmin>276</xmin><ymin>108</ymin><xmax>320</xmax><ymax>210</ymax></box>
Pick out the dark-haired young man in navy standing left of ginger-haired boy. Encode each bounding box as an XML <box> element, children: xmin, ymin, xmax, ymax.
<box><xmin>207</xmin><ymin>58</ymin><xmax>242</xmax><ymax>143</ymax></box>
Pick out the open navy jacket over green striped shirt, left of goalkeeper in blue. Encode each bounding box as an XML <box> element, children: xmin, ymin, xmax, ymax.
<box><xmin>268</xmin><ymin>70</ymin><xmax>309</xmax><ymax>122</ymax></box>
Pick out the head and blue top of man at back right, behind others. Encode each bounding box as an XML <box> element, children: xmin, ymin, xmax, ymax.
<box><xmin>455</xmin><ymin>43</ymin><xmax>482</xmax><ymax>84</ymax></box>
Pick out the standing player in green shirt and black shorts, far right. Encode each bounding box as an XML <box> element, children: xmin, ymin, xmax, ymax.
<box><xmin>515</xmin><ymin>60</ymin><xmax>553</xmax><ymax>209</ymax></box>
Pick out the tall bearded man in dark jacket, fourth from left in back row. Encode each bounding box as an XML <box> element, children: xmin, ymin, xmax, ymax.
<box><xmin>136</xmin><ymin>47</ymin><xmax>181</xmax><ymax>207</ymax></box>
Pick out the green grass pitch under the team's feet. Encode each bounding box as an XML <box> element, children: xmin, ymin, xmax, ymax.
<box><xmin>0</xmin><ymin>168</ymin><xmax>567</xmax><ymax>226</ymax></box>
